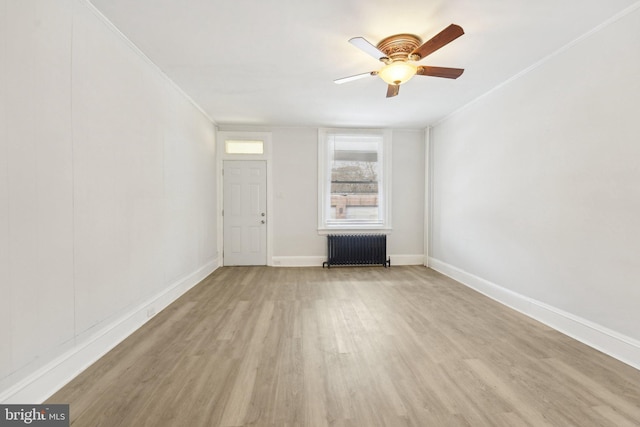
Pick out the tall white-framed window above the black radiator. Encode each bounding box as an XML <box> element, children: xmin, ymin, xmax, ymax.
<box><xmin>318</xmin><ymin>129</ymin><xmax>391</xmax><ymax>232</ymax></box>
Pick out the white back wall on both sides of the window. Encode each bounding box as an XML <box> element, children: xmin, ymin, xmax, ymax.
<box><xmin>220</xmin><ymin>125</ymin><xmax>425</xmax><ymax>266</ymax></box>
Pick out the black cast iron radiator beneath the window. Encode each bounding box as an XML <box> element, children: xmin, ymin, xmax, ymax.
<box><xmin>322</xmin><ymin>234</ymin><xmax>391</xmax><ymax>268</ymax></box>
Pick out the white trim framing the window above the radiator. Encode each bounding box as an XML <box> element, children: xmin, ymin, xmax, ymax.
<box><xmin>318</xmin><ymin>128</ymin><xmax>392</xmax><ymax>235</ymax></box>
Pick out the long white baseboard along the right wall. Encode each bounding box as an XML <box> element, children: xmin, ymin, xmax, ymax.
<box><xmin>429</xmin><ymin>258</ymin><xmax>640</xmax><ymax>369</ymax></box>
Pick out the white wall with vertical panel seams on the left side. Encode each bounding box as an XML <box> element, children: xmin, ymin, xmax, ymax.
<box><xmin>0</xmin><ymin>0</ymin><xmax>217</xmax><ymax>401</ymax></box>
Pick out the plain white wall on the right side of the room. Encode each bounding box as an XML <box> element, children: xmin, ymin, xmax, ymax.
<box><xmin>431</xmin><ymin>8</ymin><xmax>640</xmax><ymax>366</ymax></box>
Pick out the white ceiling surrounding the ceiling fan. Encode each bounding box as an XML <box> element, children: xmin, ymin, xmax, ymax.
<box><xmin>91</xmin><ymin>0</ymin><xmax>637</xmax><ymax>128</ymax></box>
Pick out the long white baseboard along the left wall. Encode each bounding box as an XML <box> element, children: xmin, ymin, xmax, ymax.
<box><xmin>0</xmin><ymin>259</ymin><xmax>218</xmax><ymax>404</ymax></box>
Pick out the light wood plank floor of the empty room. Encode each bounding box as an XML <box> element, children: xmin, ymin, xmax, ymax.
<box><xmin>49</xmin><ymin>267</ymin><xmax>640</xmax><ymax>427</ymax></box>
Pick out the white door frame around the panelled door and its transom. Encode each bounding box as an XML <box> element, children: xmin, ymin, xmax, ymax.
<box><xmin>216</xmin><ymin>127</ymin><xmax>273</xmax><ymax>266</ymax></box>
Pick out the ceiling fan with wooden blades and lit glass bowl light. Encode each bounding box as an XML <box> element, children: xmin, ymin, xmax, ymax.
<box><xmin>334</xmin><ymin>24</ymin><xmax>464</xmax><ymax>98</ymax></box>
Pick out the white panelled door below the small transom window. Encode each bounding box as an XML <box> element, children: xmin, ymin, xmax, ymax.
<box><xmin>222</xmin><ymin>160</ymin><xmax>267</xmax><ymax>265</ymax></box>
